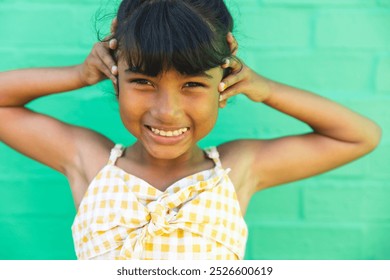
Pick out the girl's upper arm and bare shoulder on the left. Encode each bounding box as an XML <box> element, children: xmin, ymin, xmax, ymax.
<box><xmin>0</xmin><ymin>107</ymin><xmax>113</xmax><ymax>205</ymax></box>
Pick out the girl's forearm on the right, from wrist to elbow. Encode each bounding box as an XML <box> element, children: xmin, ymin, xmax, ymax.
<box><xmin>263</xmin><ymin>81</ymin><xmax>380</xmax><ymax>150</ymax></box>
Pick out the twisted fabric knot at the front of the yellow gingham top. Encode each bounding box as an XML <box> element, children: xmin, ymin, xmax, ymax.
<box><xmin>147</xmin><ymin>201</ymin><xmax>176</xmax><ymax>236</ymax></box>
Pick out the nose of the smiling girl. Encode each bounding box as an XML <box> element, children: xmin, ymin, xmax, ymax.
<box><xmin>152</xmin><ymin>91</ymin><xmax>183</xmax><ymax>123</ymax></box>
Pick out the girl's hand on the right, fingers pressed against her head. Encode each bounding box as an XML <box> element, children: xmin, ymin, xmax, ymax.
<box><xmin>218</xmin><ymin>33</ymin><xmax>272</xmax><ymax>108</ymax></box>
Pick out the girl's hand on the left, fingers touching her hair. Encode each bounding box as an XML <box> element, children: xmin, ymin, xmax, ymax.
<box><xmin>78</xmin><ymin>18</ymin><xmax>118</xmax><ymax>85</ymax></box>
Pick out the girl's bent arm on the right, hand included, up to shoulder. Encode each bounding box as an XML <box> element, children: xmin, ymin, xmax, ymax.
<box><xmin>220</xmin><ymin>52</ymin><xmax>381</xmax><ymax>191</ymax></box>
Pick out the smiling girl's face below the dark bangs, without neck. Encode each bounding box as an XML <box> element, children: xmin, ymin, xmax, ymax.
<box><xmin>118</xmin><ymin>58</ymin><xmax>223</xmax><ymax>159</ymax></box>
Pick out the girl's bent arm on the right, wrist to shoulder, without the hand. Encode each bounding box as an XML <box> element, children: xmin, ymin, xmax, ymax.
<box><xmin>257</xmin><ymin>82</ymin><xmax>381</xmax><ymax>188</ymax></box>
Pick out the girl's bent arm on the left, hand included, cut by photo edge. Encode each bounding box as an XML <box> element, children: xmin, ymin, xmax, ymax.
<box><xmin>0</xmin><ymin>40</ymin><xmax>115</xmax><ymax>174</ymax></box>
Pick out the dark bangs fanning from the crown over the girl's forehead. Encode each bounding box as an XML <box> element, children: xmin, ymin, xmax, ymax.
<box><xmin>117</xmin><ymin>1</ymin><xmax>230</xmax><ymax>76</ymax></box>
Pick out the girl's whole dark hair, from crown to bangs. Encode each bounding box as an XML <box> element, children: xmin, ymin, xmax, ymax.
<box><xmin>113</xmin><ymin>0</ymin><xmax>233</xmax><ymax>76</ymax></box>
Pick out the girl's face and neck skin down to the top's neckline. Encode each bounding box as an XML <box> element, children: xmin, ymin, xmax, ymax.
<box><xmin>111</xmin><ymin>61</ymin><xmax>223</xmax><ymax>190</ymax></box>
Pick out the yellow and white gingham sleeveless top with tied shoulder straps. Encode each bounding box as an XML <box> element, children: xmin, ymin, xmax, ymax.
<box><xmin>72</xmin><ymin>145</ymin><xmax>248</xmax><ymax>260</ymax></box>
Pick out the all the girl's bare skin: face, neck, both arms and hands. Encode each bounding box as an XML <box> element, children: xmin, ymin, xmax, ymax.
<box><xmin>0</xmin><ymin>23</ymin><xmax>381</xmax><ymax>214</ymax></box>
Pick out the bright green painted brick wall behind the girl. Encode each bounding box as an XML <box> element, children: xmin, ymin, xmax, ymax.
<box><xmin>0</xmin><ymin>0</ymin><xmax>390</xmax><ymax>259</ymax></box>
